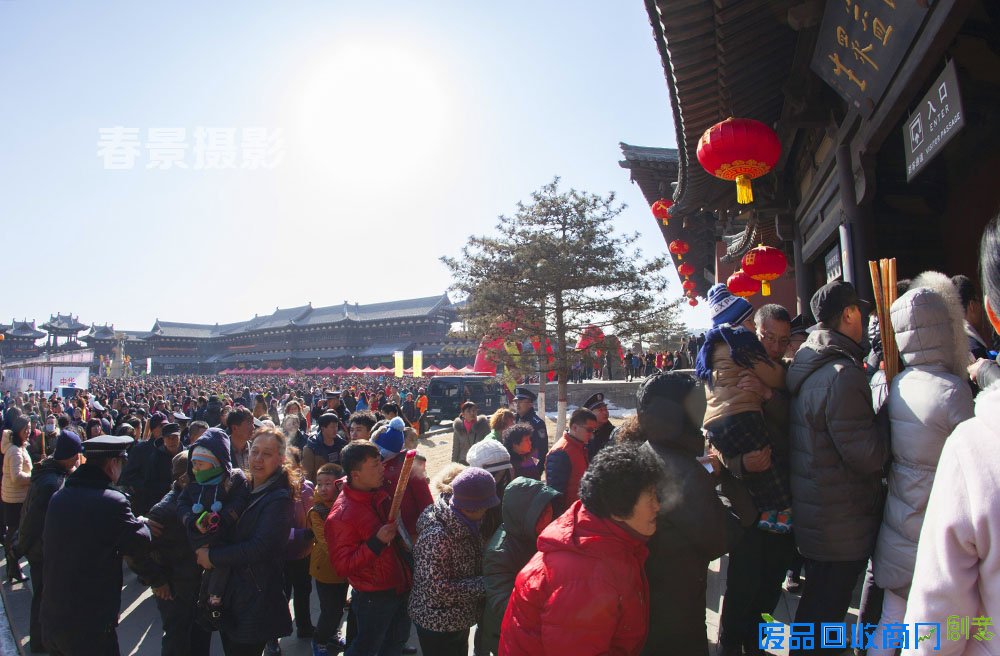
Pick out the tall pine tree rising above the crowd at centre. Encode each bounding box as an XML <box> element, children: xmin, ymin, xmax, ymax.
<box><xmin>441</xmin><ymin>177</ymin><xmax>679</xmax><ymax>437</ymax></box>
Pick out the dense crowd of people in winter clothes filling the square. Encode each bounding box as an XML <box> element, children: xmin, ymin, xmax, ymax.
<box><xmin>0</xmin><ymin>217</ymin><xmax>1000</xmax><ymax>656</ymax></box>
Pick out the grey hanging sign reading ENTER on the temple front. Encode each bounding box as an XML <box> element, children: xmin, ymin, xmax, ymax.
<box><xmin>903</xmin><ymin>61</ymin><xmax>965</xmax><ymax>182</ymax></box>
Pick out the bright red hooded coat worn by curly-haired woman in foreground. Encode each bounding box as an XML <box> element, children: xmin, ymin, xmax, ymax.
<box><xmin>500</xmin><ymin>501</ymin><xmax>649</xmax><ymax>656</ymax></box>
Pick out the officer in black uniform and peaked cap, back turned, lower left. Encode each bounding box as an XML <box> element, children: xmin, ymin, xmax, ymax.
<box><xmin>41</xmin><ymin>435</ymin><xmax>151</xmax><ymax>656</ymax></box>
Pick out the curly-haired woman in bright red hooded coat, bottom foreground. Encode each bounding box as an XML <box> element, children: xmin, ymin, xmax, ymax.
<box><xmin>500</xmin><ymin>444</ymin><xmax>660</xmax><ymax>656</ymax></box>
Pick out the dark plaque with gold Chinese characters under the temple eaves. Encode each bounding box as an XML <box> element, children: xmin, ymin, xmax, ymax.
<box><xmin>812</xmin><ymin>0</ymin><xmax>927</xmax><ymax>116</ymax></box>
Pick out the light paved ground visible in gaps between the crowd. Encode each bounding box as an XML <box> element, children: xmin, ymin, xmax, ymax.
<box><xmin>0</xmin><ymin>419</ymin><xmax>861</xmax><ymax>656</ymax></box>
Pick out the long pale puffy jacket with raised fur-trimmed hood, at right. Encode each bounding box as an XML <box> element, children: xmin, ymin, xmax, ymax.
<box><xmin>872</xmin><ymin>272</ymin><xmax>973</xmax><ymax>598</ymax></box>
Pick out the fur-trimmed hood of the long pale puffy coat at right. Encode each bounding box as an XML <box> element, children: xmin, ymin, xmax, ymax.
<box><xmin>890</xmin><ymin>271</ymin><xmax>969</xmax><ymax>378</ymax></box>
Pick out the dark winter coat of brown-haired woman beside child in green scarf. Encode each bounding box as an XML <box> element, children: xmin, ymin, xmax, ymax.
<box><xmin>208</xmin><ymin>473</ymin><xmax>295</xmax><ymax>643</ymax></box>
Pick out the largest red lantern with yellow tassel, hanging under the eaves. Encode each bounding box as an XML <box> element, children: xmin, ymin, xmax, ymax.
<box><xmin>698</xmin><ymin>117</ymin><xmax>781</xmax><ymax>205</ymax></box>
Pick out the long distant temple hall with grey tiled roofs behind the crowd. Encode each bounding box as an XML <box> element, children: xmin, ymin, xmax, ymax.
<box><xmin>0</xmin><ymin>294</ymin><xmax>476</xmax><ymax>374</ymax></box>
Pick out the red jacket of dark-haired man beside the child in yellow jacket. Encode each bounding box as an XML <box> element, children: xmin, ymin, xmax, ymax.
<box><xmin>323</xmin><ymin>479</ymin><xmax>411</xmax><ymax>594</ymax></box>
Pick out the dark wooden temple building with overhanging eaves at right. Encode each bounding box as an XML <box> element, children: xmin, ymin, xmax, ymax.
<box><xmin>620</xmin><ymin>0</ymin><xmax>1000</xmax><ymax>324</ymax></box>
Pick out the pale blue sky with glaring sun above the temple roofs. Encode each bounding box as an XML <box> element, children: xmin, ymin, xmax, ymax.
<box><xmin>0</xmin><ymin>0</ymin><xmax>704</xmax><ymax>330</ymax></box>
